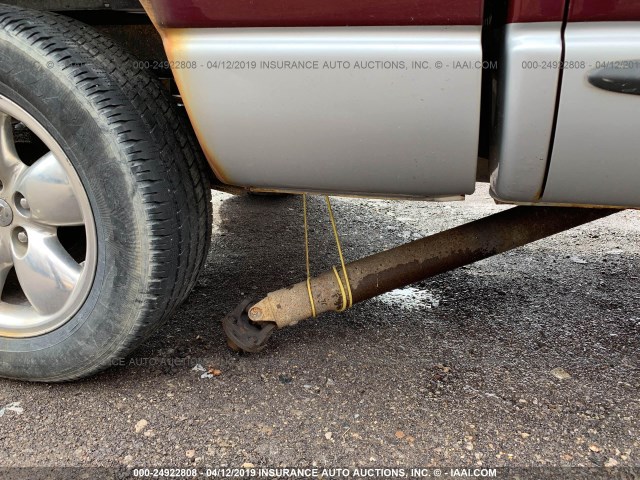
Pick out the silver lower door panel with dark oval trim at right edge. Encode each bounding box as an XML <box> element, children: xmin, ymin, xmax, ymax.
<box><xmin>542</xmin><ymin>22</ymin><xmax>640</xmax><ymax>207</ymax></box>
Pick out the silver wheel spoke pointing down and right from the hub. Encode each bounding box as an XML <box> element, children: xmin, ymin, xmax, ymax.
<box><xmin>13</xmin><ymin>229</ymin><xmax>82</xmax><ymax>315</ymax></box>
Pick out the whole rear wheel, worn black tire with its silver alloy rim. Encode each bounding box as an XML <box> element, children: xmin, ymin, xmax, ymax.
<box><xmin>0</xmin><ymin>5</ymin><xmax>212</xmax><ymax>382</ymax></box>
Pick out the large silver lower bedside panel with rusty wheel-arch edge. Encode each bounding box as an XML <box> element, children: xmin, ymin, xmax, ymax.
<box><xmin>165</xmin><ymin>26</ymin><xmax>482</xmax><ymax>196</ymax></box>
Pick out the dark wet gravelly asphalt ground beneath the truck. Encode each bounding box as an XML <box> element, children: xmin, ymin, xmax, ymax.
<box><xmin>0</xmin><ymin>186</ymin><xmax>640</xmax><ymax>467</ymax></box>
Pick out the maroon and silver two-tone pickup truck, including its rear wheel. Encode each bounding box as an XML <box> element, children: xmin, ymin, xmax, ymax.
<box><xmin>0</xmin><ymin>0</ymin><xmax>640</xmax><ymax>382</ymax></box>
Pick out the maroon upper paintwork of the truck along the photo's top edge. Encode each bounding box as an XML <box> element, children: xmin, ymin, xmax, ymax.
<box><xmin>151</xmin><ymin>0</ymin><xmax>640</xmax><ymax>28</ymax></box>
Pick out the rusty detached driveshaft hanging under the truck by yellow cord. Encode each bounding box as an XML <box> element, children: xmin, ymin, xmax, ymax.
<box><xmin>224</xmin><ymin>206</ymin><xmax>620</xmax><ymax>351</ymax></box>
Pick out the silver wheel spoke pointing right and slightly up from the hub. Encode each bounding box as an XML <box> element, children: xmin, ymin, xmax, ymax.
<box><xmin>15</xmin><ymin>152</ymin><xmax>83</xmax><ymax>226</ymax></box>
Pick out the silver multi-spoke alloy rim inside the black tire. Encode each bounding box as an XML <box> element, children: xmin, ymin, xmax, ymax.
<box><xmin>0</xmin><ymin>95</ymin><xmax>97</xmax><ymax>338</ymax></box>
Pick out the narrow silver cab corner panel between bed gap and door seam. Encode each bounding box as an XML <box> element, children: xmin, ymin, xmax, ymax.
<box><xmin>490</xmin><ymin>22</ymin><xmax>562</xmax><ymax>201</ymax></box>
